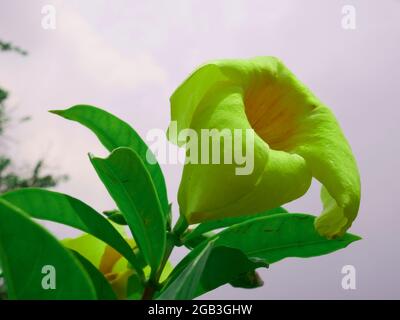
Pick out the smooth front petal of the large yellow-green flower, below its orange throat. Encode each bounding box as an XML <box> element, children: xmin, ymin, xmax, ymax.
<box><xmin>173</xmin><ymin>84</ymin><xmax>311</xmax><ymax>223</ymax></box>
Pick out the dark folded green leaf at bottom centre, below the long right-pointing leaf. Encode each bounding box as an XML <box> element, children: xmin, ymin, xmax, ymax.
<box><xmin>158</xmin><ymin>241</ymin><xmax>267</xmax><ymax>300</ymax></box>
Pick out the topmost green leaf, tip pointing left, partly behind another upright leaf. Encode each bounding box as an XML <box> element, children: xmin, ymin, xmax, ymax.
<box><xmin>50</xmin><ymin>105</ymin><xmax>169</xmax><ymax>216</ymax></box>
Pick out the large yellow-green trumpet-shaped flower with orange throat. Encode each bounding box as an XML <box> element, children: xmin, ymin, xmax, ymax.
<box><xmin>169</xmin><ymin>57</ymin><xmax>360</xmax><ymax>238</ymax></box>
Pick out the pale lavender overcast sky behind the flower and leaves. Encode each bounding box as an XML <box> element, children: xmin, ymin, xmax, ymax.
<box><xmin>0</xmin><ymin>0</ymin><xmax>400</xmax><ymax>299</ymax></box>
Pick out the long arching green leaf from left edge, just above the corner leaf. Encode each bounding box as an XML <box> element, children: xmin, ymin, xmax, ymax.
<box><xmin>0</xmin><ymin>188</ymin><xmax>141</xmax><ymax>272</ymax></box>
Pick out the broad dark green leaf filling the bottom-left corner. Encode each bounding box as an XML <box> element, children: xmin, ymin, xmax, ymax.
<box><xmin>0</xmin><ymin>199</ymin><xmax>96</xmax><ymax>300</ymax></box>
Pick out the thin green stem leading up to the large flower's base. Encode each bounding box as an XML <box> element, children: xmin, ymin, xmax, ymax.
<box><xmin>142</xmin><ymin>215</ymin><xmax>188</xmax><ymax>300</ymax></box>
